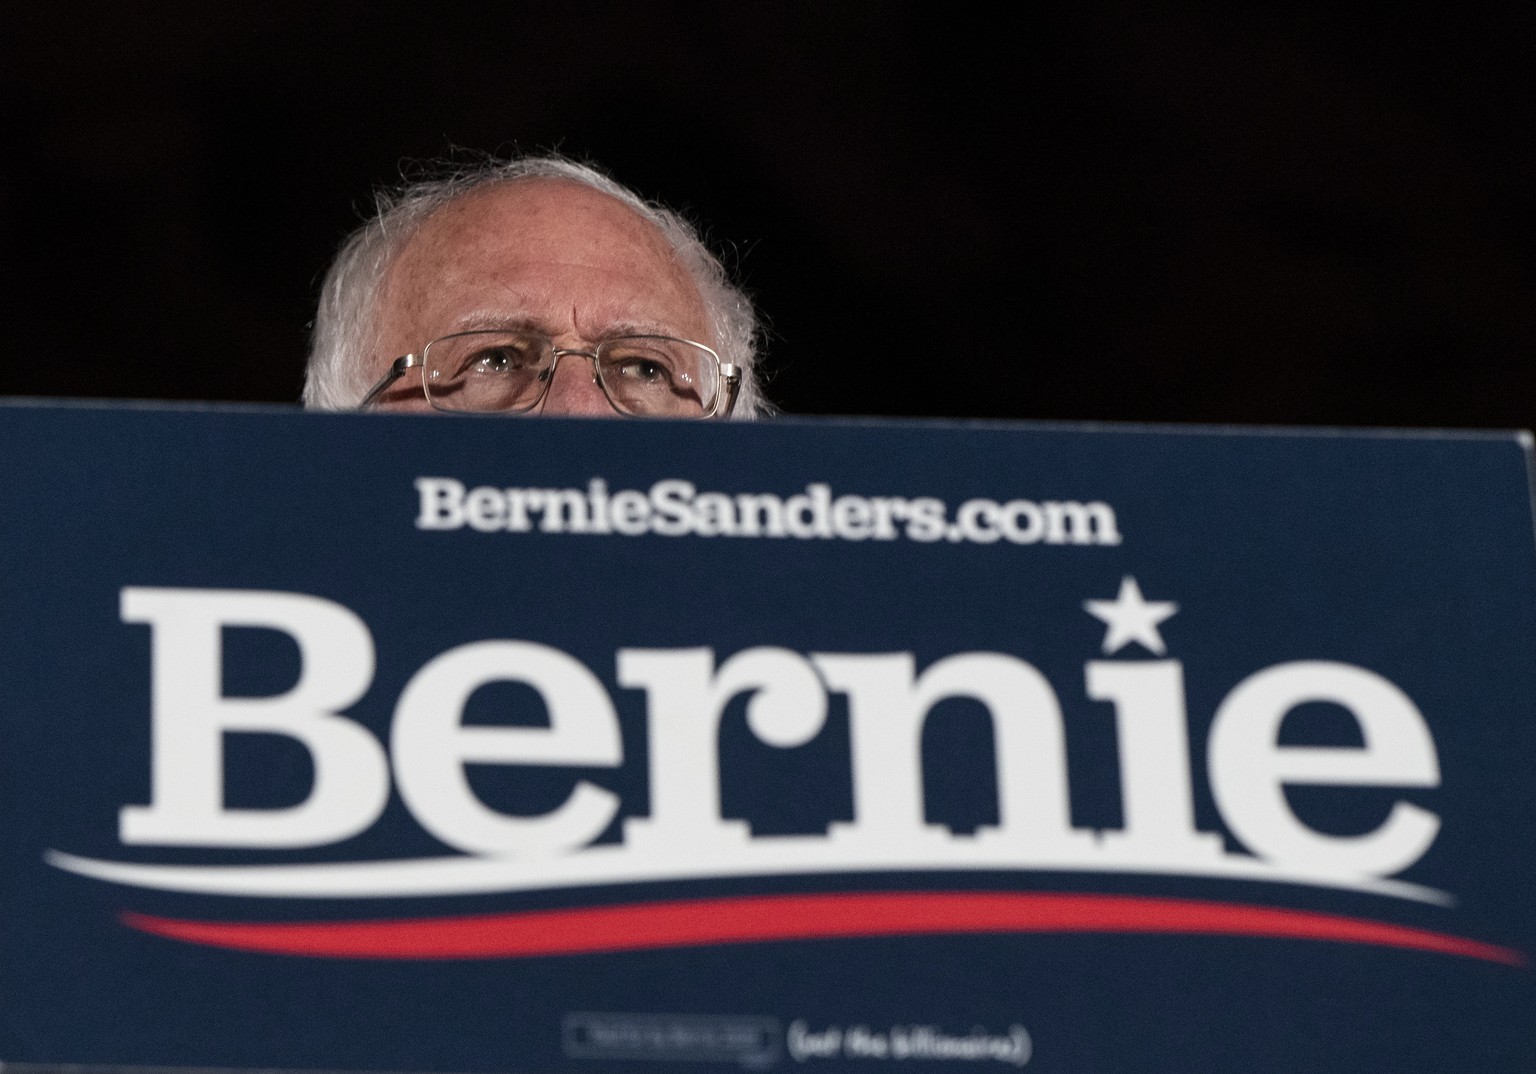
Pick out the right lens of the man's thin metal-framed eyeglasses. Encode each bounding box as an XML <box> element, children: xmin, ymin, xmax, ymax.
<box><xmin>598</xmin><ymin>335</ymin><xmax>720</xmax><ymax>418</ymax></box>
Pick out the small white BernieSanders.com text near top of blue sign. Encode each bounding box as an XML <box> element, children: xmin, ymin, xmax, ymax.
<box><xmin>415</xmin><ymin>478</ymin><xmax>1120</xmax><ymax>545</ymax></box>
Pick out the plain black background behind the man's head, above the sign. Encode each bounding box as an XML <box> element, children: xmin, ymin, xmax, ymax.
<box><xmin>0</xmin><ymin>3</ymin><xmax>1536</xmax><ymax>426</ymax></box>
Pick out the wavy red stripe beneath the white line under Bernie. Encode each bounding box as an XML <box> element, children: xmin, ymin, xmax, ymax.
<box><xmin>123</xmin><ymin>891</ymin><xmax>1525</xmax><ymax>966</ymax></box>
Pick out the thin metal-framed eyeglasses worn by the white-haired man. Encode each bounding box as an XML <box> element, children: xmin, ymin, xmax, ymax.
<box><xmin>358</xmin><ymin>329</ymin><xmax>742</xmax><ymax>418</ymax></box>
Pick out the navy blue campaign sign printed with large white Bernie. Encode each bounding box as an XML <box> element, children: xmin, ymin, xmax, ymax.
<box><xmin>0</xmin><ymin>404</ymin><xmax>1536</xmax><ymax>1074</ymax></box>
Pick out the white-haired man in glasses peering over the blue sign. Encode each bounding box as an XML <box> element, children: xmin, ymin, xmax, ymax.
<box><xmin>304</xmin><ymin>157</ymin><xmax>768</xmax><ymax>418</ymax></box>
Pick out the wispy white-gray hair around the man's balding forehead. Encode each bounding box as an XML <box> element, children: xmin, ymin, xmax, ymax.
<box><xmin>304</xmin><ymin>155</ymin><xmax>773</xmax><ymax>418</ymax></box>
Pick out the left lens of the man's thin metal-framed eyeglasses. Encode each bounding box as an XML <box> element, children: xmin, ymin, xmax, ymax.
<box><xmin>424</xmin><ymin>332</ymin><xmax>553</xmax><ymax>410</ymax></box>
